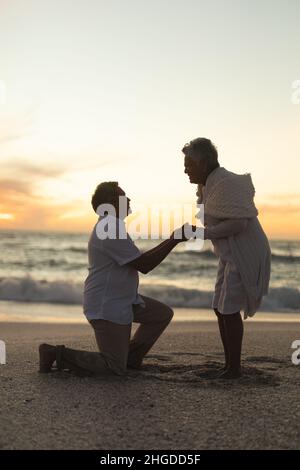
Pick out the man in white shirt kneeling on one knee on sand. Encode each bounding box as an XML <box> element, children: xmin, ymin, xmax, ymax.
<box><xmin>39</xmin><ymin>182</ymin><xmax>192</xmax><ymax>376</ymax></box>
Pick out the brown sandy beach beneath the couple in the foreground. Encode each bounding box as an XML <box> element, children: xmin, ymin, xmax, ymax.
<box><xmin>0</xmin><ymin>310</ymin><xmax>300</xmax><ymax>450</ymax></box>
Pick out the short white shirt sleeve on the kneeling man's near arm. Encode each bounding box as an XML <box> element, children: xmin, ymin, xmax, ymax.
<box><xmin>102</xmin><ymin>236</ymin><xmax>141</xmax><ymax>266</ymax></box>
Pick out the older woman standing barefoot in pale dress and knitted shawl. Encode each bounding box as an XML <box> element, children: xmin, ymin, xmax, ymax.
<box><xmin>182</xmin><ymin>137</ymin><xmax>271</xmax><ymax>379</ymax></box>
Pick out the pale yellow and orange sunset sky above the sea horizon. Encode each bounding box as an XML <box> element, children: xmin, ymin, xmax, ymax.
<box><xmin>0</xmin><ymin>0</ymin><xmax>300</xmax><ymax>238</ymax></box>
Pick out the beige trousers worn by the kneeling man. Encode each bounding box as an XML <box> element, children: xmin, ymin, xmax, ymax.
<box><xmin>58</xmin><ymin>296</ymin><xmax>173</xmax><ymax>375</ymax></box>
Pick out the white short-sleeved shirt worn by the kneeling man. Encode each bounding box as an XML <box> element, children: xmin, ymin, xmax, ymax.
<box><xmin>83</xmin><ymin>219</ymin><xmax>144</xmax><ymax>325</ymax></box>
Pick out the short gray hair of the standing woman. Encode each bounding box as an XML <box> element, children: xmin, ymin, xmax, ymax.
<box><xmin>182</xmin><ymin>137</ymin><xmax>219</xmax><ymax>167</ymax></box>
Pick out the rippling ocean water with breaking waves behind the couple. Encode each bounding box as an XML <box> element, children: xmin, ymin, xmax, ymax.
<box><xmin>0</xmin><ymin>231</ymin><xmax>300</xmax><ymax>313</ymax></box>
